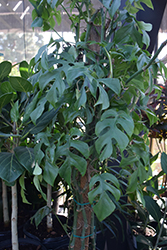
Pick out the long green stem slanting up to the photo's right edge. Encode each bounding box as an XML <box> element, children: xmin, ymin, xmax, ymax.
<box><xmin>126</xmin><ymin>40</ymin><xmax>167</xmax><ymax>84</ymax></box>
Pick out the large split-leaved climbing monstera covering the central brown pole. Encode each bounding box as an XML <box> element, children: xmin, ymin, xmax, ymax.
<box><xmin>18</xmin><ymin>0</ymin><xmax>166</xmax><ymax>250</ymax></box>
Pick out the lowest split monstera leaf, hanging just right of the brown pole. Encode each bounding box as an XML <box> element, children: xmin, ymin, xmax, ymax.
<box><xmin>88</xmin><ymin>173</ymin><xmax>121</xmax><ymax>221</ymax></box>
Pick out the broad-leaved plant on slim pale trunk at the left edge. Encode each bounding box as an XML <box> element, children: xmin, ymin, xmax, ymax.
<box><xmin>0</xmin><ymin>61</ymin><xmax>45</xmax><ymax>249</ymax></box>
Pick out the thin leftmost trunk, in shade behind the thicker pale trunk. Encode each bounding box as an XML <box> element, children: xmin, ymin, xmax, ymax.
<box><xmin>2</xmin><ymin>180</ymin><xmax>9</xmax><ymax>227</ymax></box>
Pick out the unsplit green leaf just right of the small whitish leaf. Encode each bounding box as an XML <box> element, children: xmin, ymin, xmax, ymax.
<box><xmin>43</xmin><ymin>161</ymin><xmax>59</xmax><ymax>186</ymax></box>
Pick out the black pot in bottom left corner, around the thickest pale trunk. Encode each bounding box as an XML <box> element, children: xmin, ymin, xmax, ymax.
<box><xmin>0</xmin><ymin>238</ymin><xmax>47</xmax><ymax>250</ymax></box>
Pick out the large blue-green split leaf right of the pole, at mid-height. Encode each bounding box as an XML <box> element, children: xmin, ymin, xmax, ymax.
<box><xmin>95</xmin><ymin>109</ymin><xmax>134</xmax><ymax>161</ymax></box>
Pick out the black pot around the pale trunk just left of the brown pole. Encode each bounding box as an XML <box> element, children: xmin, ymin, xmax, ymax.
<box><xmin>23</xmin><ymin>215</ymin><xmax>70</xmax><ymax>249</ymax></box>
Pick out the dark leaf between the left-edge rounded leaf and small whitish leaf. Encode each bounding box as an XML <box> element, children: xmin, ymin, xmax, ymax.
<box><xmin>14</xmin><ymin>147</ymin><xmax>35</xmax><ymax>174</ymax></box>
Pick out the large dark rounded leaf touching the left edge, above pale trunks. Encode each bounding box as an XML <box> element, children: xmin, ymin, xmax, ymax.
<box><xmin>0</xmin><ymin>152</ymin><xmax>25</xmax><ymax>183</ymax></box>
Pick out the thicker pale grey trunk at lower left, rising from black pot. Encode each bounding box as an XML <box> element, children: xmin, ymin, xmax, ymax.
<box><xmin>11</xmin><ymin>182</ymin><xmax>19</xmax><ymax>250</ymax></box>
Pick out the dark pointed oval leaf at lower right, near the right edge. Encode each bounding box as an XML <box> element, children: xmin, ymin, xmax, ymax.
<box><xmin>144</xmin><ymin>196</ymin><xmax>162</xmax><ymax>222</ymax></box>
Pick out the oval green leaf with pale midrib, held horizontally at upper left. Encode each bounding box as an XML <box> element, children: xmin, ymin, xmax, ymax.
<box><xmin>9</xmin><ymin>76</ymin><xmax>33</xmax><ymax>92</ymax></box>
